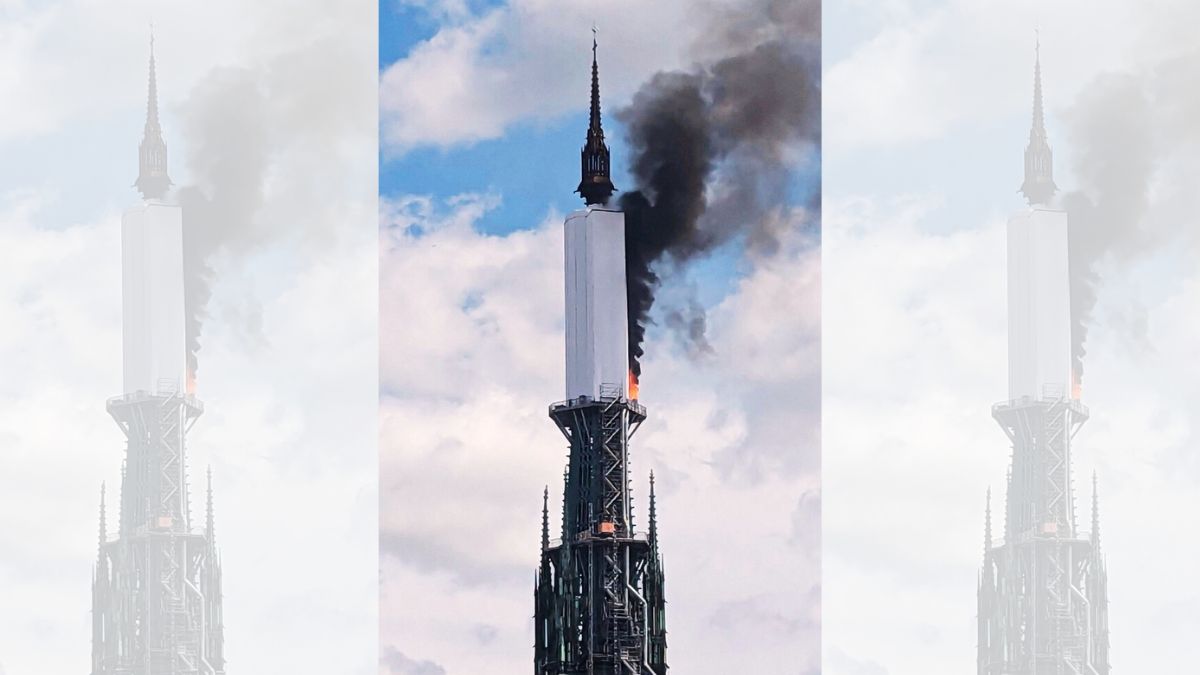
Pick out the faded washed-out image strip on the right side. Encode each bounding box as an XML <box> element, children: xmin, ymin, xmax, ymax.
<box><xmin>823</xmin><ymin>1</ymin><xmax>1200</xmax><ymax>675</ymax></box>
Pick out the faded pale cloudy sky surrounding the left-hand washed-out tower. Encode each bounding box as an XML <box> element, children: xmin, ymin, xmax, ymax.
<box><xmin>0</xmin><ymin>0</ymin><xmax>377</xmax><ymax>675</ymax></box>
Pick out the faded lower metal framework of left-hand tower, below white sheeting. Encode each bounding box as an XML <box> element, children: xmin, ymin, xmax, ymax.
<box><xmin>91</xmin><ymin>392</ymin><xmax>224</xmax><ymax>675</ymax></box>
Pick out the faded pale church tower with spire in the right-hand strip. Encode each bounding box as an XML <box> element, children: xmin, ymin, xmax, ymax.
<box><xmin>977</xmin><ymin>43</ymin><xmax>1110</xmax><ymax>675</ymax></box>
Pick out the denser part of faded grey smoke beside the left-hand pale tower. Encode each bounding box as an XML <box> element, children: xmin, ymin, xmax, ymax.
<box><xmin>178</xmin><ymin>68</ymin><xmax>271</xmax><ymax>381</ymax></box>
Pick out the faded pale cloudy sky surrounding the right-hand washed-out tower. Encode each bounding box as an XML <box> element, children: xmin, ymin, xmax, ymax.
<box><xmin>823</xmin><ymin>0</ymin><xmax>1200</xmax><ymax>675</ymax></box>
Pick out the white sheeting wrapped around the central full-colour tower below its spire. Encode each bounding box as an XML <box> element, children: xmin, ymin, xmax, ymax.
<box><xmin>565</xmin><ymin>207</ymin><xmax>629</xmax><ymax>399</ymax></box>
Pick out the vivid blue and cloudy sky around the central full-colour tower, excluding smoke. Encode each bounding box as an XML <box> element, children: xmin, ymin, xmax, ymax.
<box><xmin>379</xmin><ymin>0</ymin><xmax>820</xmax><ymax>675</ymax></box>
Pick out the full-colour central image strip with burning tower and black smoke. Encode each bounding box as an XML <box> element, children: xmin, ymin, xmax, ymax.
<box><xmin>379</xmin><ymin>0</ymin><xmax>821</xmax><ymax>675</ymax></box>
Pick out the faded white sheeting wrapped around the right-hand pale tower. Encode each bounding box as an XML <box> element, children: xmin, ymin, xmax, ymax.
<box><xmin>1008</xmin><ymin>208</ymin><xmax>1072</xmax><ymax>399</ymax></box>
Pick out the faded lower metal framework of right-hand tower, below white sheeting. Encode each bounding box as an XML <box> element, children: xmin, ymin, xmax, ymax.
<box><xmin>978</xmin><ymin>393</ymin><xmax>1110</xmax><ymax>675</ymax></box>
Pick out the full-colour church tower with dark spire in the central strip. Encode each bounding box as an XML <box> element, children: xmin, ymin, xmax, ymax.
<box><xmin>534</xmin><ymin>41</ymin><xmax>667</xmax><ymax>675</ymax></box>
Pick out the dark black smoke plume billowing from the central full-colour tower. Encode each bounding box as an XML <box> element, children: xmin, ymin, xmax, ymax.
<box><xmin>617</xmin><ymin>13</ymin><xmax>821</xmax><ymax>375</ymax></box>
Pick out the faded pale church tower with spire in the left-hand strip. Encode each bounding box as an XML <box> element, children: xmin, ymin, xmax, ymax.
<box><xmin>91</xmin><ymin>38</ymin><xmax>224</xmax><ymax>675</ymax></box>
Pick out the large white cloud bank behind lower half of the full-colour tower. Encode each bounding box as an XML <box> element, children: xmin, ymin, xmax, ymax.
<box><xmin>380</xmin><ymin>196</ymin><xmax>820</xmax><ymax>675</ymax></box>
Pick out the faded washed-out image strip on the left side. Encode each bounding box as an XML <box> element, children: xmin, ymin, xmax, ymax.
<box><xmin>0</xmin><ymin>0</ymin><xmax>378</xmax><ymax>675</ymax></box>
